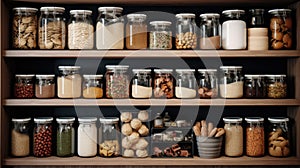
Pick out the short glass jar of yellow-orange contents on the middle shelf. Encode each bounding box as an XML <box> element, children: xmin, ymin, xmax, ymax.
<box><xmin>82</xmin><ymin>75</ymin><xmax>103</xmax><ymax>99</ymax></box>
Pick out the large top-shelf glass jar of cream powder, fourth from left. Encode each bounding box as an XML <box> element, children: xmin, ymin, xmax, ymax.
<box><xmin>96</xmin><ymin>7</ymin><xmax>124</xmax><ymax>49</ymax></box>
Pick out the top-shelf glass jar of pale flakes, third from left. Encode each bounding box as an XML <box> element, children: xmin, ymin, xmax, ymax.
<box><xmin>68</xmin><ymin>10</ymin><xmax>94</xmax><ymax>49</ymax></box>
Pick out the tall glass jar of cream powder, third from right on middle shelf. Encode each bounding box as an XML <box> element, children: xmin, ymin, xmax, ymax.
<box><xmin>220</xmin><ymin>66</ymin><xmax>244</xmax><ymax>98</ymax></box>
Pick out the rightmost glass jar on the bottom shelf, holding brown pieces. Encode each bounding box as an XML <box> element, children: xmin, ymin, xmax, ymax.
<box><xmin>268</xmin><ymin>117</ymin><xmax>291</xmax><ymax>157</ymax></box>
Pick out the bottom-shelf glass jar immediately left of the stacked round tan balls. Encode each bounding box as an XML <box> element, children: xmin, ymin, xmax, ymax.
<box><xmin>99</xmin><ymin>118</ymin><xmax>120</xmax><ymax>157</ymax></box>
